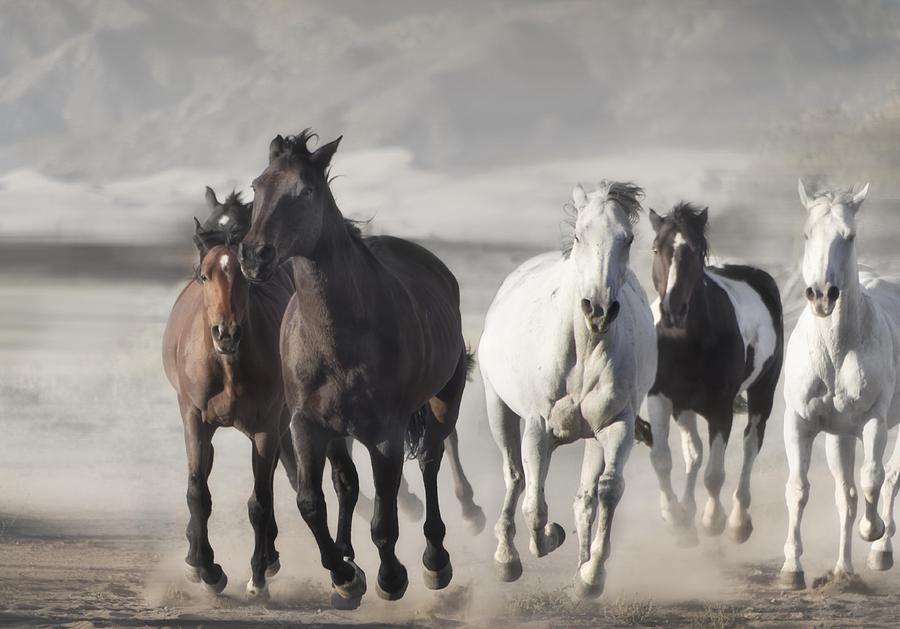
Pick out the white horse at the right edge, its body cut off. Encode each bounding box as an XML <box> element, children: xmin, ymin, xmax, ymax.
<box><xmin>781</xmin><ymin>181</ymin><xmax>900</xmax><ymax>589</ymax></box>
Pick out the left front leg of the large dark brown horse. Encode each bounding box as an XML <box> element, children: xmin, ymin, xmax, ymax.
<box><xmin>291</xmin><ymin>415</ymin><xmax>366</xmax><ymax>609</ymax></box>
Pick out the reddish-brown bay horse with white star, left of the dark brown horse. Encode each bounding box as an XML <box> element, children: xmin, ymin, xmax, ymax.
<box><xmin>163</xmin><ymin>188</ymin><xmax>296</xmax><ymax>599</ymax></box>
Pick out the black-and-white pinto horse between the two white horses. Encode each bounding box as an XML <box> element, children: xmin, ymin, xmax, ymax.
<box><xmin>647</xmin><ymin>203</ymin><xmax>784</xmax><ymax>546</ymax></box>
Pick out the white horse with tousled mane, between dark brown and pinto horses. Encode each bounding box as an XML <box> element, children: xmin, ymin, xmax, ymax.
<box><xmin>479</xmin><ymin>182</ymin><xmax>656</xmax><ymax>597</ymax></box>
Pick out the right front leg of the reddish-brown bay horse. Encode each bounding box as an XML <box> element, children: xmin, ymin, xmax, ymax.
<box><xmin>247</xmin><ymin>432</ymin><xmax>281</xmax><ymax>600</ymax></box>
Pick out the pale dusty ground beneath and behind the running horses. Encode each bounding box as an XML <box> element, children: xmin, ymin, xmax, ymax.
<box><xmin>0</xmin><ymin>230</ymin><xmax>900</xmax><ymax>627</ymax></box>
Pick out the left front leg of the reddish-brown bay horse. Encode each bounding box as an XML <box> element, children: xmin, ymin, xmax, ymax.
<box><xmin>179</xmin><ymin>400</ymin><xmax>228</xmax><ymax>594</ymax></box>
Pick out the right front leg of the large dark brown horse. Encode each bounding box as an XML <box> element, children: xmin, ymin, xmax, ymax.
<box><xmin>369</xmin><ymin>426</ymin><xmax>409</xmax><ymax>601</ymax></box>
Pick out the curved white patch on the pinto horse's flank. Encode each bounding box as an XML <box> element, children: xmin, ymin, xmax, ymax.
<box><xmin>706</xmin><ymin>269</ymin><xmax>777</xmax><ymax>391</ymax></box>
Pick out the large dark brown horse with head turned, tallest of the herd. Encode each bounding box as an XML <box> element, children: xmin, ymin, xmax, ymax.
<box><xmin>240</xmin><ymin>129</ymin><xmax>472</xmax><ymax>607</ymax></box>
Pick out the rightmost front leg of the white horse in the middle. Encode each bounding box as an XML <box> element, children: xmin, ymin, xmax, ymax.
<box><xmin>575</xmin><ymin>420</ymin><xmax>634</xmax><ymax>598</ymax></box>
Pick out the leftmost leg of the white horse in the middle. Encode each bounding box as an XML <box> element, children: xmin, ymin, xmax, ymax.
<box><xmin>484</xmin><ymin>378</ymin><xmax>525</xmax><ymax>582</ymax></box>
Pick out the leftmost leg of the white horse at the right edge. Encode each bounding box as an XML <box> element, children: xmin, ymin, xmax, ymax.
<box><xmin>780</xmin><ymin>408</ymin><xmax>815</xmax><ymax>590</ymax></box>
